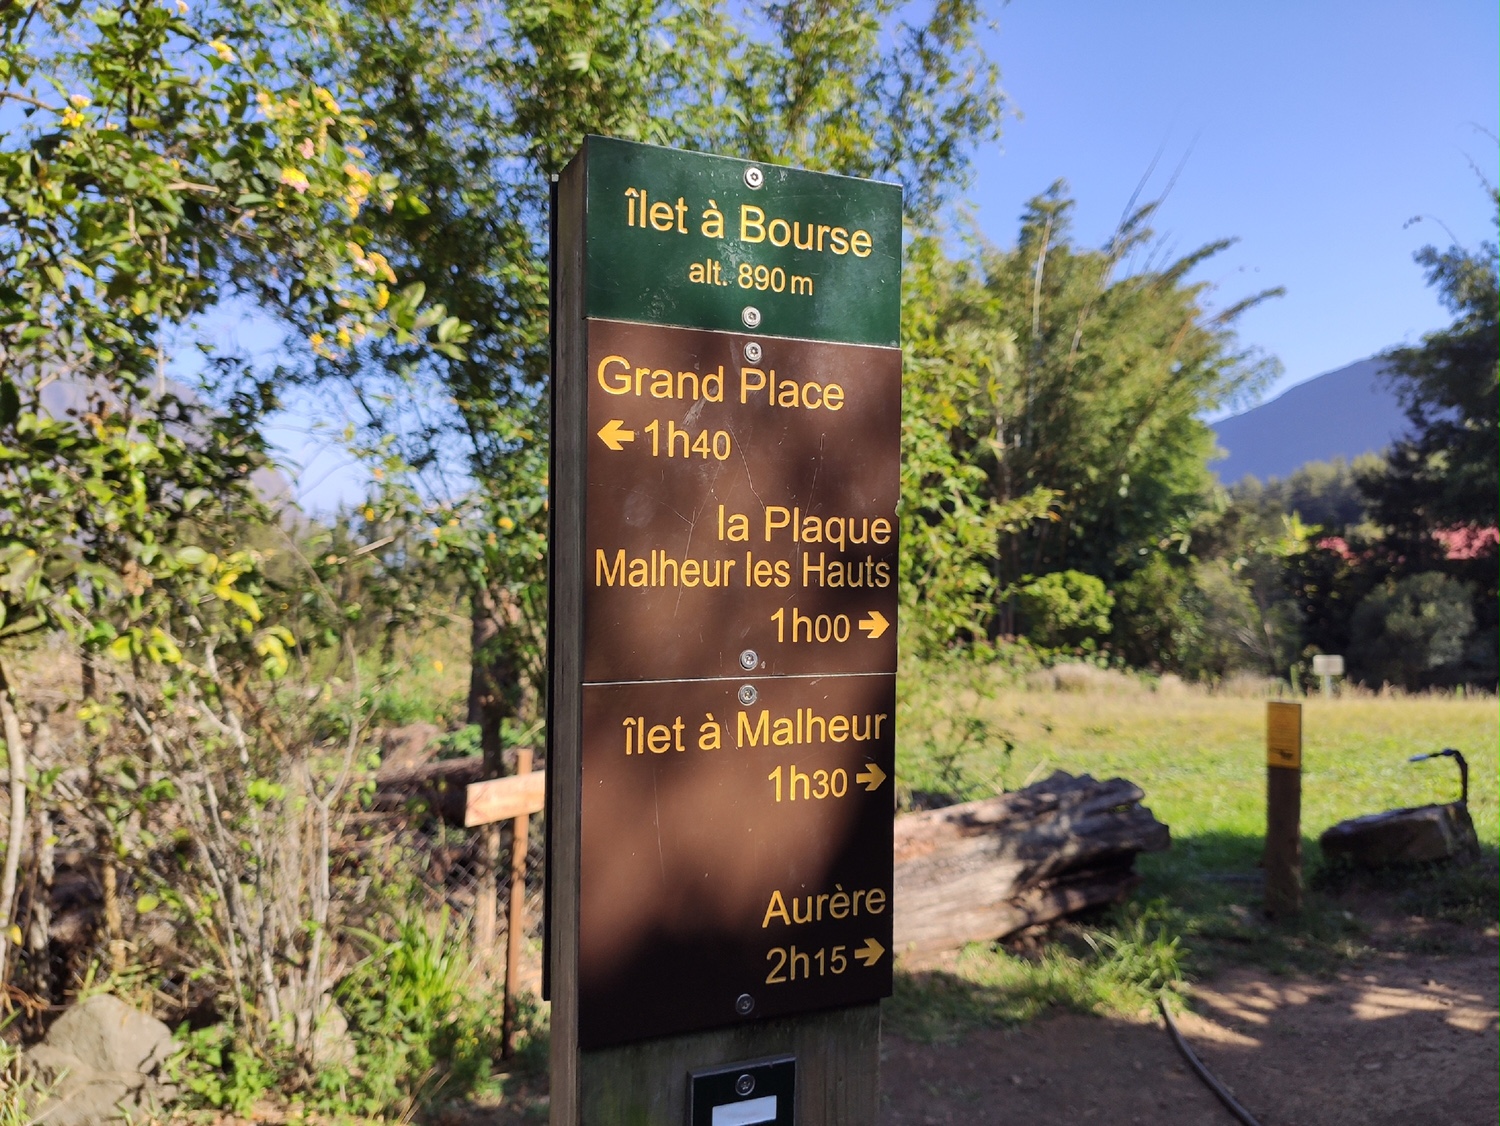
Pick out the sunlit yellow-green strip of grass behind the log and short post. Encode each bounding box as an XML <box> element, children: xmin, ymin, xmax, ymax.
<box><xmin>897</xmin><ymin>670</ymin><xmax>1500</xmax><ymax>862</ymax></box>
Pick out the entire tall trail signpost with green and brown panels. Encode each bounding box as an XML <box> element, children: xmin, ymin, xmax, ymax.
<box><xmin>548</xmin><ymin>138</ymin><xmax>902</xmax><ymax>1126</ymax></box>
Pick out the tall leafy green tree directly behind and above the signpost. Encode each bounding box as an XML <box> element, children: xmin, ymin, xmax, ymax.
<box><xmin>252</xmin><ymin>0</ymin><xmax>1004</xmax><ymax>740</ymax></box>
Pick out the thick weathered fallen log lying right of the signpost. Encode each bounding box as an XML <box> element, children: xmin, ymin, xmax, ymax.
<box><xmin>894</xmin><ymin>771</ymin><xmax>1172</xmax><ymax>952</ymax></box>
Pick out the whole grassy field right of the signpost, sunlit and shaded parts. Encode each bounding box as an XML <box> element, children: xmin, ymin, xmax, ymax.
<box><xmin>893</xmin><ymin>670</ymin><xmax>1500</xmax><ymax>1036</ymax></box>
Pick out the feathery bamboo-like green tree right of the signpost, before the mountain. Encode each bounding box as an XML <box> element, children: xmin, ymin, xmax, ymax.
<box><xmin>941</xmin><ymin>183</ymin><xmax>1278</xmax><ymax>631</ymax></box>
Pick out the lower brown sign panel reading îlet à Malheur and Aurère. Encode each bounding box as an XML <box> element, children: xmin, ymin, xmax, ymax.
<box><xmin>578</xmin><ymin>675</ymin><xmax>896</xmax><ymax>1048</ymax></box>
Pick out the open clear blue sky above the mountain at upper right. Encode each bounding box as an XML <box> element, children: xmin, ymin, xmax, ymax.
<box><xmin>969</xmin><ymin>0</ymin><xmax>1500</xmax><ymax>394</ymax></box>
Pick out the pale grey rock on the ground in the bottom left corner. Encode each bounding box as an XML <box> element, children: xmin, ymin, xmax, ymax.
<box><xmin>24</xmin><ymin>996</ymin><xmax>173</xmax><ymax>1126</ymax></box>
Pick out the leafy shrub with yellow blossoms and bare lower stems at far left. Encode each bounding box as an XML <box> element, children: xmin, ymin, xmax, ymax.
<box><xmin>0</xmin><ymin>0</ymin><xmax>443</xmax><ymax>1029</ymax></box>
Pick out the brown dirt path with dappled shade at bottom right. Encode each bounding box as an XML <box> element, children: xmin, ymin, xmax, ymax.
<box><xmin>881</xmin><ymin>942</ymin><xmax>1500</xmax><ymax>1126</ymax></box>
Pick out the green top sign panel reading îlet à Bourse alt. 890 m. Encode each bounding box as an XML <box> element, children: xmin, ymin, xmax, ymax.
<box><xmin>587</xmin><ymin>136</ymin><xmax>902</xmax><ymax>348</ymax></box>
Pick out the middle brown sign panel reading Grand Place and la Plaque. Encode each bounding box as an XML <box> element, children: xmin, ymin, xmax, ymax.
<box><xmin>584</xmin><ymin>321</ymin><xmax>902</xmax><ymax>682</ymax></box>
